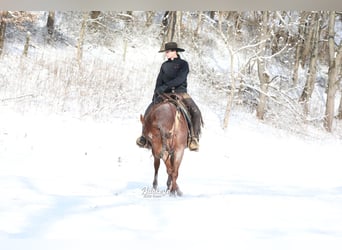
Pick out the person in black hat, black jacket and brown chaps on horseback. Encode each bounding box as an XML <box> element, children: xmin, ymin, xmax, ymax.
<box><xmin>136</xmin><ymin>42</ymin><xmax>202</xmax><ymax>151</ymax></box>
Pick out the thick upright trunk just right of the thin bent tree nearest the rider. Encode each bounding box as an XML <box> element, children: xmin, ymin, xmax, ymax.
<box><xmin>256</xmin><ymin>11</ymin><xmax>270</xmax><ymax>120</ymax></box>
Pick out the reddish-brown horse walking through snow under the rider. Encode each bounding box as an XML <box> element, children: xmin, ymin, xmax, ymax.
<box><xmin>140</xmin><ymin>94</ymin><xmax>189</xmax><ymax>196</ymax></box>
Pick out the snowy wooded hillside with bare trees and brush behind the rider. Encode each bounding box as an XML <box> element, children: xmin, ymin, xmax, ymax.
<box><xmin>0</xmin><ymin>11</ymin><xmax>342</xmax><ymax>137</ymax></box>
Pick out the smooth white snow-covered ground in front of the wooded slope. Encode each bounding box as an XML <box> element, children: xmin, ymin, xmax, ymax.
<box><xmin>0</xmin><ymin>103</ymin><xmax>342</xmax><ymax>250</ymax></box>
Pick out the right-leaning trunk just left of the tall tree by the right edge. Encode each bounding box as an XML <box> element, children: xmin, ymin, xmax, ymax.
<box><xmin>299</xmin><ymin>14</ymin><xmax>320</xmax><ymax>114</ymax></box>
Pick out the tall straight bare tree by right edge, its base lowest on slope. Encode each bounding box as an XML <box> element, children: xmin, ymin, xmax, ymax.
<box><xmin>324</xmin><ymin>11</ymin><xmax>342</xmax><ymax>132</ymax></box>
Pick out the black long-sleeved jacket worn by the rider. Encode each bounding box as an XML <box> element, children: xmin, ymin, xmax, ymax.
<box><xmin>154</xmin><ymin>56</ymin><xmax>189</xmax><ymax>94</ymax></box>
